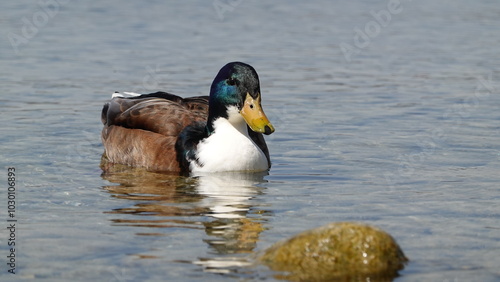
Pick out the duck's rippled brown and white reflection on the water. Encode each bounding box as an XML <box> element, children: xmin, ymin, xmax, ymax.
<box><xmin>102</xmin><ymin>164</ymin><xmax>269</xmax><ymax>272</ymax></box>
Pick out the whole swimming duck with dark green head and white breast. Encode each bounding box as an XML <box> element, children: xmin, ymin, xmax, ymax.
<box><xmin>101</xmin><ymin>62</ymin><xmax>275</xmax><ymax>175</ymax></box>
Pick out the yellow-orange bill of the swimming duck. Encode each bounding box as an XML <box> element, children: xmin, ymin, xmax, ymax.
<box><xmin>240</xmin><ymin>93</ymin><xmax>274</xmax><ymax>135</ymax></box>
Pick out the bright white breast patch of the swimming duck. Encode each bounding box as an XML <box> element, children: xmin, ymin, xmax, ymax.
<box><xmin>190</xmin><ymin>109</ymin><xmax>269</xmax><ymax>173</ymax></box>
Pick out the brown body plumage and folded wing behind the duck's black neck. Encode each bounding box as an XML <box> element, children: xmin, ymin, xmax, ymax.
<box><xmin>101</xmin><ymin>92</ymin><xmax>208</xmax><ymax>172</ymax></box>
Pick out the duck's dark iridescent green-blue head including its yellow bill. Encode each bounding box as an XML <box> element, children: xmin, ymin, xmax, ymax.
<box><xmin>208</xmin><ymin>62</ymin><xmax>274</xmax><ymax>134</ymax></box>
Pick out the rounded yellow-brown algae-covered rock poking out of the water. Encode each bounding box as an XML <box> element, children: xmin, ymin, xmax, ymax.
<box><xmin>258</xmin><ymin>222</ymin><xmax>408</xmax><ymax>281</ymax></box>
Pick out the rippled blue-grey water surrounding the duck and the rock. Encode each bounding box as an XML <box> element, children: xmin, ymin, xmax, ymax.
<box><xmin>0</xmin><ymin>0</ymin><xmax>500</xmax><ymax>281</ymax></box>
